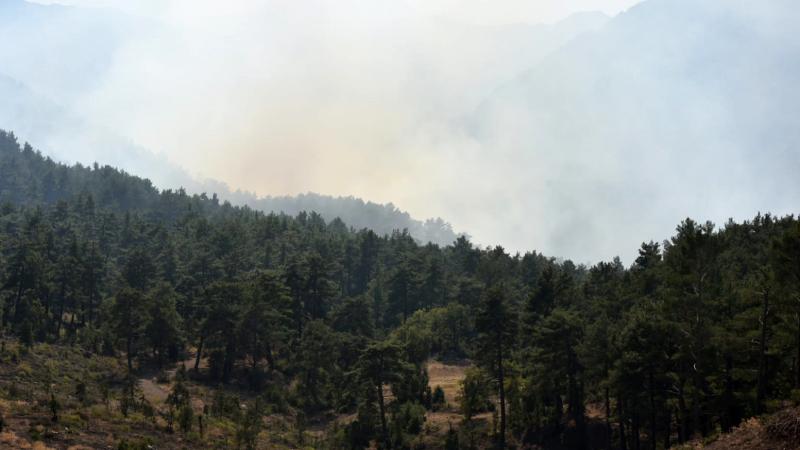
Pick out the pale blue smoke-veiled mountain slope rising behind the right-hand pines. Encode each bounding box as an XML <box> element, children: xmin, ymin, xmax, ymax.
<box><xmin>467</xmin><ymin>0</ymin><xmax>800</xmax><ymax>255</ymax></box>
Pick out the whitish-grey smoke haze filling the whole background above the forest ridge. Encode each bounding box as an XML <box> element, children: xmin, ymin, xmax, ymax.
<box><xmin>0</xmin><ymin>0</ymin><xmax>800</xmax><ymax>261</ymax></box>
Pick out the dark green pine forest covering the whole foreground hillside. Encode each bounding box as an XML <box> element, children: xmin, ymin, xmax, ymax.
<box><xmin>0</xmin><ymin>128</ymin><xmax>800</xmax><ymax>449</ymax></box>
